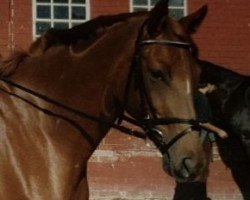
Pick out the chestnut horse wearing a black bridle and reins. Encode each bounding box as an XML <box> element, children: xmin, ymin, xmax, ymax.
<box><xmin>0</xmin><ymin>1</ymin><xmax>208</xmax><ymax>200</ymax></box>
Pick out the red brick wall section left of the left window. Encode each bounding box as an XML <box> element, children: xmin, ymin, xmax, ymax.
<box><xmin>0</xmin><ymin>0</ymin><xmax>32</xmax><ymax>56</ymax></box>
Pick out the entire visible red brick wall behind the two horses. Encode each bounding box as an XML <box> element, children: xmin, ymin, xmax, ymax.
<box><xmin>0</xmin><ymin>0</ymin><xmax>250</xmax><ymax>200</ymax></box>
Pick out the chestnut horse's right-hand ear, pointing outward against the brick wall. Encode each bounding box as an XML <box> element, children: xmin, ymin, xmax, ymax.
<box><xmin>179</xmin><ymin>5</ymin><xmax>208</xmax><ymax>34</ymax></box>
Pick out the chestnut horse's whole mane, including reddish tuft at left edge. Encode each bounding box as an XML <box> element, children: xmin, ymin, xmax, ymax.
<box><xmin>0</xmin><ymin>12</ymin><xmax>146</xmax><ymax>76</ymax></box>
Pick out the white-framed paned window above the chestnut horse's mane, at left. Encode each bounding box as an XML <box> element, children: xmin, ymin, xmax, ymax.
<box><xmin>33</xmin><ymin>0</ymin><xmax>90</xmax><ymax>38</ymax></box>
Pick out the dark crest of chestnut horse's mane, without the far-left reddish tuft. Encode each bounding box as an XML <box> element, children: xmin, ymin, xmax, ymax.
<box><xmin>29</xmin><ymin>12</ymin><xmax>146</xmax><ymax>55</ymax></box>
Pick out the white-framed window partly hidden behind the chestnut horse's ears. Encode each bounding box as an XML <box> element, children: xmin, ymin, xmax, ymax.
<box><xmin>130</xmin><ymin>0</ymin><xmax>187</xmax><ymax>19</ymax></box>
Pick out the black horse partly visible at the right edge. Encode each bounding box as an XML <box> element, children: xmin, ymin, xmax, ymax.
<box><xmin>200</xmin><ymin>61</ymin><xmax>250</xmax><ymax>200</ymax></box>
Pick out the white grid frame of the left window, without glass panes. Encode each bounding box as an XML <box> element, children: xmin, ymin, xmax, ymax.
<box><xmin>32</xmin><ymin>0</ymin><xmax>91</xmax><ymax>39</ymax></box>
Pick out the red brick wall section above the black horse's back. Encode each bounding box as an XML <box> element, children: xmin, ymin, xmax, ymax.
<box><xmin>189</xmin><ymin>0</ymin><xmax>250</xmax><ymax>74</ymax></box>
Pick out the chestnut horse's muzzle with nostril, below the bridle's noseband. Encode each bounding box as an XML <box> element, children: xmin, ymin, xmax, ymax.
<box><xmin>147</xmin><ymin>126</ymin><xmax>206</xmax><ymax>182</ymax></box>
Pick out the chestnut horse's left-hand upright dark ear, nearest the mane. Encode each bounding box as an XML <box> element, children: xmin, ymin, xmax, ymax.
<box><xmin>147</xmin><ymin>0</ymin><xmax>168</xmax><ymax>37</ymax></box>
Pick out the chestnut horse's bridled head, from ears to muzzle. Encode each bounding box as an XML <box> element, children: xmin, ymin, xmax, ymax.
<box><xmin>127</xmin><ymin>1</ymin><xmax>208</xmax><ymax>182</ymax></box>
